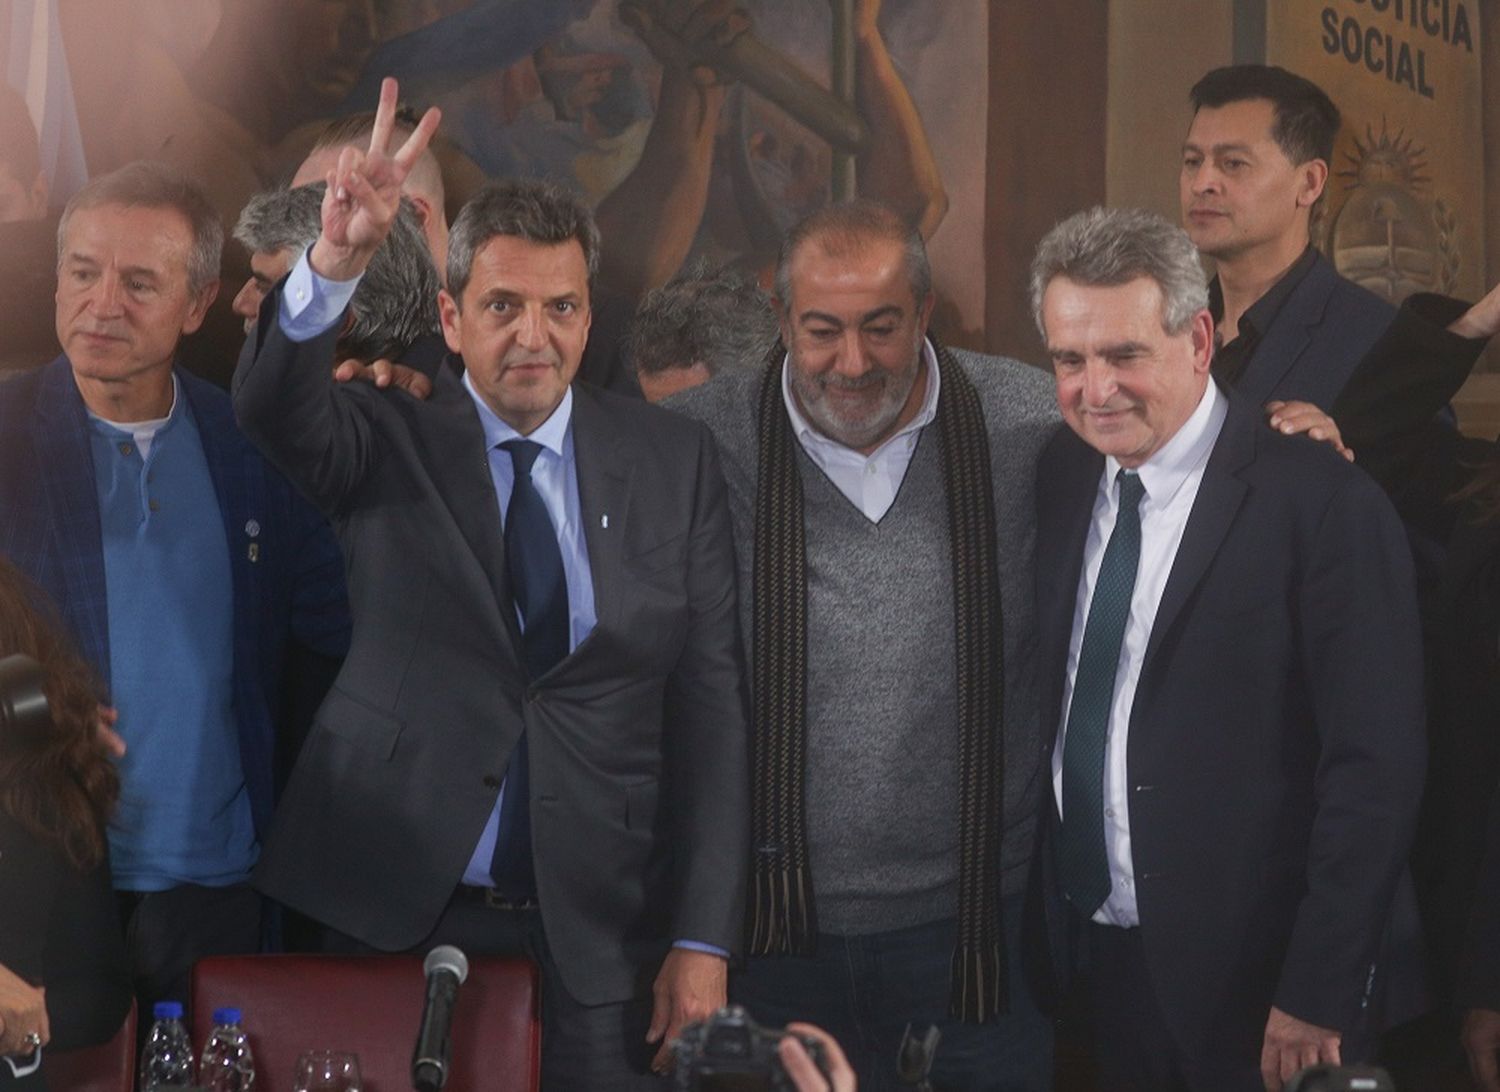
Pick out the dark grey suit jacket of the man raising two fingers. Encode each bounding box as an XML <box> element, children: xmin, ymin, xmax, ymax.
<box><xmin>234</xmin><ymin>291</ymin><xmax>749</xmax><ymax>1004</ymax></box>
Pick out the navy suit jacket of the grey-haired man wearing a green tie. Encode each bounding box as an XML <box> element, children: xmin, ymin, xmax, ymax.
<box><xmin>1037</xmin><ymin>398</ymin><xmax>1427</xmax><ymax>1068</ymax></box>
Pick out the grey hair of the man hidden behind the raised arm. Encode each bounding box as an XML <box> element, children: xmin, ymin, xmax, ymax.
<box><xmin>234</xmin><ymin>182</ymin><xmax>443</xmax><ymax>363</ymax></box>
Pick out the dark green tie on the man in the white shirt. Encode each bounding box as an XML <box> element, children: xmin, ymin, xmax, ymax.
<box><xmin>1058</xmin><ymin>470</ymin><xmax>1146</xmax><ymax>918</ymax></box>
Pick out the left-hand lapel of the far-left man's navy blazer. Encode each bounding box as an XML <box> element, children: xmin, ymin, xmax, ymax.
<box><xmin>32</xmin><ymin>357</ymin><xmax>110</xmax><ymax>686</ymax></box>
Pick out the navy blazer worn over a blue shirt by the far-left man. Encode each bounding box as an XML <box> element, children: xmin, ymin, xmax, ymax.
<box><xmin>0</xmin><ymin>356</ymin><xmax>350</xmax><ymax>834</ymax></box>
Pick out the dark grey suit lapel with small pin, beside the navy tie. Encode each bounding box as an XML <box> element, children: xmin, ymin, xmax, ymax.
<box><xmin>573</xmin><ymin>384</ymin><xmax>635</xmax><ymax>639</ymax></box>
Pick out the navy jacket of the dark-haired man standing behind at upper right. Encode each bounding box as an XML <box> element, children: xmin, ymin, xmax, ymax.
<box><xmin>1235</xmin><ymin>254</ymin><xmax>1397</xmax><ymax>410</ymax></box>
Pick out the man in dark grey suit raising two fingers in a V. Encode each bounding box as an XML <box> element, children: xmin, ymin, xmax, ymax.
<box><xmin>234</xmin><ymin>81</ymin><xmax>750</xmax><ymax>1089</ymax></box>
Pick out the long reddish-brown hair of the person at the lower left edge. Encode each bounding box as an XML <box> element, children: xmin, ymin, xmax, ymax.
<box><xmin>0</xmin><ymin>560</ymin><xmax>120</xmax><ymax>870</ymax></box>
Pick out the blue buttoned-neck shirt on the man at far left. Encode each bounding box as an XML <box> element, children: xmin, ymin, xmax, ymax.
<box><xmin>90</xmin><ymin>381</ymin><xmax>258</xmax><ymax>891</ymax></box>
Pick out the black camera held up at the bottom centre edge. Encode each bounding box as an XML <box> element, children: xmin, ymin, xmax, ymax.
<box><xmin>672</xmin><ymin>1005</ymin><xmax>828</xmax><ymax>1092</ymax></box>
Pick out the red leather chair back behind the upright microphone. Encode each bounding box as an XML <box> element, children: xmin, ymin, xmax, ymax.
<box><xmin>192</xmin><ymin>956</ymin><xmax>542</xmax><ymax>1092</ymax></box>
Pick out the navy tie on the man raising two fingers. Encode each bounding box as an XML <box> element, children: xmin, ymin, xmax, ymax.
<box><xmin>491</xmin><ymin>440</ymin><xmax>569</xmax><ymax>899</ymax></box>
